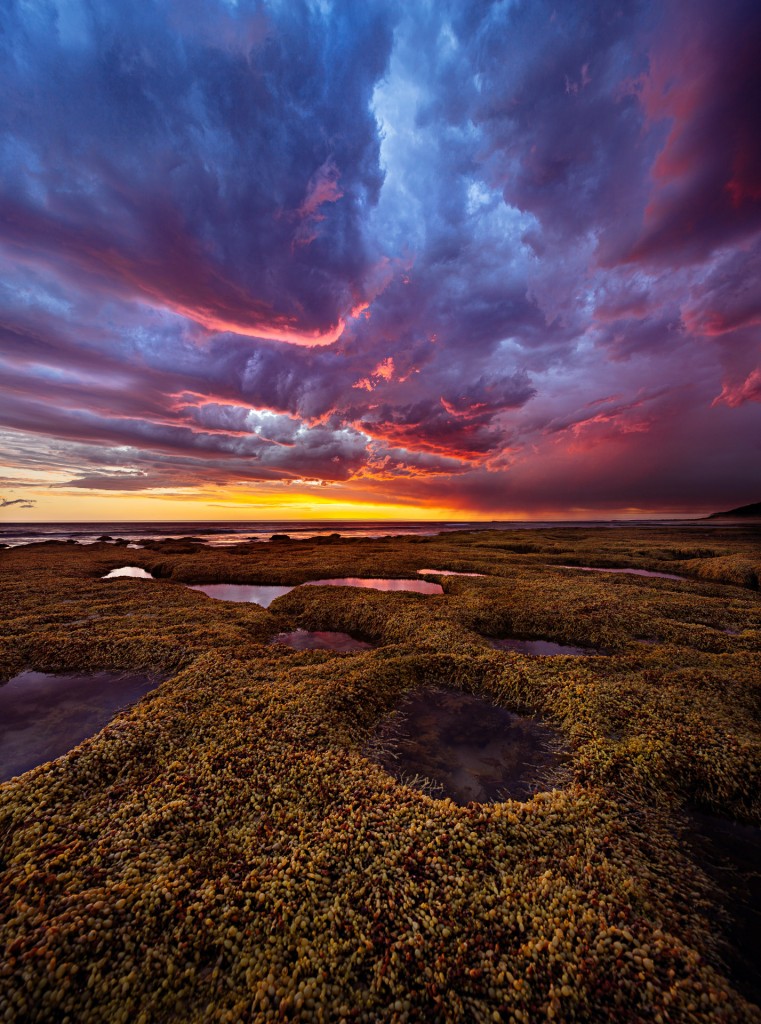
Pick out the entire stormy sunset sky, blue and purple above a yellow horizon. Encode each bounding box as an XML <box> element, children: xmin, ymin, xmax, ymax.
<box><xmin>0</xmin><ymin>0</ymin><xmax>761</xmax><ymax>521</ymax></box>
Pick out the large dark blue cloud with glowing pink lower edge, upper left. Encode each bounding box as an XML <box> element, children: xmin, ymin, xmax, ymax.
<box><xmin>0</xmin><ymin>0</ymin><xmax>392</xmax><ymax>340</ymax></box>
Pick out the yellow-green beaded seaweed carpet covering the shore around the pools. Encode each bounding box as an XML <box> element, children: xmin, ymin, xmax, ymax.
<box><xmin>0</xmin><ymin>527</ymin><xmax>761</xmax><ymax>1024</ymax></box>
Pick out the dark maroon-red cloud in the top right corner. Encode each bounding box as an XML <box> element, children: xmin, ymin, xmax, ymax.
<box><xmin>631</xmin><ymin>0</ymin><xmax>761</xmax><ymax>261</ymax></box>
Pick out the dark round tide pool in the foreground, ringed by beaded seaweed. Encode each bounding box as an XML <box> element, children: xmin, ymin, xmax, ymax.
<box><xmin>371</xmin><ymin>689</ymin><xmax>566</xmax><ymax>804</ymax></box>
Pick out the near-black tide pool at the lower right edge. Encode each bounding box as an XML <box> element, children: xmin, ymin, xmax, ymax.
<box><xmin>685</xmin><ymin>810</ymin><xmax>761</xmax><ymax>1002</ymax></box>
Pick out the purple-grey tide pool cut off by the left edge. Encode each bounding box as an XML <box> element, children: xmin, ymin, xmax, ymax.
<box><xmin>0</xmin><ymin>672</ymin><xmax>165</xmax><ymax>782</ymax></box>
